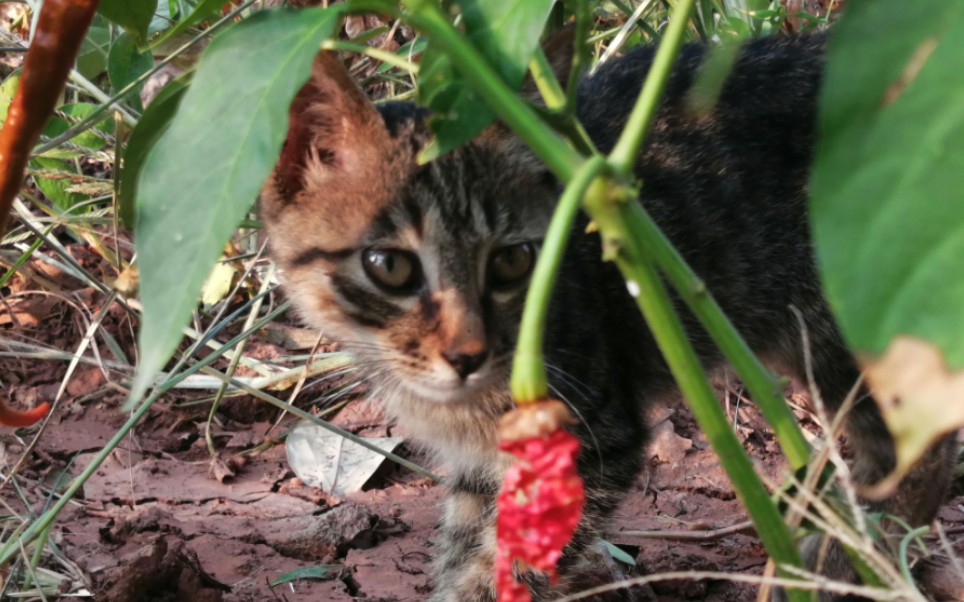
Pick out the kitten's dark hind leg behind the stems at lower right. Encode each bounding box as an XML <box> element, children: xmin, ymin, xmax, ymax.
<box><xmin>774</xmin><ymin>333</ymin><xmax>956</xmax><ymax>602</ymax></box>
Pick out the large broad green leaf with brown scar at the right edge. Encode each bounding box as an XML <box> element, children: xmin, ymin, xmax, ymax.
<box><xmin>812</xmin><ymin>0</ymin><xmax>964</xmax><ymax>369</ymax></box>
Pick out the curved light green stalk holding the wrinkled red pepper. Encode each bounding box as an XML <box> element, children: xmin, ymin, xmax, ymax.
<box><xmin>510</xmin><ymin>155</ymin><xmax>606</xmax><ymax>403</ymax></box>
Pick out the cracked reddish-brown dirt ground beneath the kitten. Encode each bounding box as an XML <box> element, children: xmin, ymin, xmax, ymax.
<box><xmin>0</xmin><ymin>253</ymin><xmax>964</xmax><ymax>602</ymax></box>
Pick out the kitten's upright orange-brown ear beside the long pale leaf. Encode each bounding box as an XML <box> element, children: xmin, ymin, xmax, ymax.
<box><xmin>260</xmin><ymin>52</ymin><xmax>418</xmax><ymax>265</ymax></box>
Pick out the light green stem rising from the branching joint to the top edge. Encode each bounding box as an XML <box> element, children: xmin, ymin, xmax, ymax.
<box><xmin>609</xmin><ymin>0</ymin><xmax>696</xmax><ymax>178</ymax></box>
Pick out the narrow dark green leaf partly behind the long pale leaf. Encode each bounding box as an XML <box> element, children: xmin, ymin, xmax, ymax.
<box><xmin>117</xmin><ymin>74</ymin><xmax>191</xmax><ymax>229</ymax></box>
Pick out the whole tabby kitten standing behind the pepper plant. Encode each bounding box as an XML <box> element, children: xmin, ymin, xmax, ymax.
<box><xmin>261</xmin><ymin>36</ymin><xmax>951</xmax><ymax>602</ymax></box>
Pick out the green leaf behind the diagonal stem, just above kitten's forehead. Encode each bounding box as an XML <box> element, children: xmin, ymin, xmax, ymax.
<box><xmin>418</xmin><ymin>0</ymin><xmax>555</xmax><ymax>160</ymax></box>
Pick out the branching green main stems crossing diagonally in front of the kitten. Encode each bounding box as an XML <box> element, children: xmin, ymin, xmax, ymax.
<box><xmin>388</xmin><ymin>0</ymin><xmax>806</xmax><ymax>601</ymax></box>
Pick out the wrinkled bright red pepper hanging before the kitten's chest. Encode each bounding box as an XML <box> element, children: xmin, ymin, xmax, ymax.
<box><xmin>495</xmin><ymin>401</ymin><xmax>585</xmax><ymax>602</ymax></box>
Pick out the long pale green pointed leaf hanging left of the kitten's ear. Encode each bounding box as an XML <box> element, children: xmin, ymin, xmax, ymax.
<box><xmin>130</xmin><ymin>5</ymin><xmax>344</xmax><ymax>402</ymax></box>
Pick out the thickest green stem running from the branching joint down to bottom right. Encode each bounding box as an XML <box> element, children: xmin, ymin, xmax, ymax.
<box><xmin>585</xmin><ymin>180</ymin><xmax>807</xmax><ymax>601</ymax></box>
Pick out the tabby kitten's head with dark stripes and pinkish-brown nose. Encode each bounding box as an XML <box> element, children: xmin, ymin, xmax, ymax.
<box><xmin>261</xmin><ymin>53</ymin><xmax>557</xmax><ymax>404</ymax></box>
